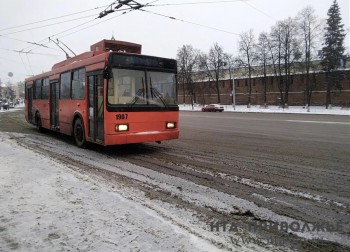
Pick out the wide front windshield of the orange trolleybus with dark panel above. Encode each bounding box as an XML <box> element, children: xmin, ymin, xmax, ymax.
<box><xmin>107</xmin><ymin>53</ymin><xmax>178</xmax><ymax>111</ymax></box>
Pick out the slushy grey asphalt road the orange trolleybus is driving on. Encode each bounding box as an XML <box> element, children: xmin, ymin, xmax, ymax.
<box><xmin>0</xmin><ymin>111</ymin><xmax>350</xmax><ymax>251</ymax></box>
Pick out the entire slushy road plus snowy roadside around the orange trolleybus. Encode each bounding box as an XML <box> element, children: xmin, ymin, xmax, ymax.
<box><xmin>0</xmin><ymin>107</ymin><xmax>350</xmax><ymax>252</ymax></box>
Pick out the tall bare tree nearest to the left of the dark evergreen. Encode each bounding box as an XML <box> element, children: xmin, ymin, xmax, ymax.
<box><xmin>298</xmin><ymin>6</ymin><xmax>322</xmax><ymax>107</ymax></box>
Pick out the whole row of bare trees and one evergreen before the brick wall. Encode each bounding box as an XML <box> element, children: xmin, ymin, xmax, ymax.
<box><xmin>177</xmin><ymin>0</ymin><xmax>347</xmax><ymax>108</ymax></box>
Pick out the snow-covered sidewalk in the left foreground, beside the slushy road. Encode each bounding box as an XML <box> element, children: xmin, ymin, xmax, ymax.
<box><xmin>0</xmin><ymin>133</ymin><xmax>221</xmax><ymax>251</ymax></box>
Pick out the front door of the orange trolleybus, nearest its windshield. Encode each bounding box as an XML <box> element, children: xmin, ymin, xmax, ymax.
<box><xmin>88</xmin><ymin>75</ymin><xmax>104</xmax><ymax>143</ymax></box>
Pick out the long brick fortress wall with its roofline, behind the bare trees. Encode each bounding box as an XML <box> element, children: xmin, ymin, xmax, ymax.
<box><xmin>178</xmin><ymin>63</ymin><xmax>350</xmax><ymax>106</ymax></box>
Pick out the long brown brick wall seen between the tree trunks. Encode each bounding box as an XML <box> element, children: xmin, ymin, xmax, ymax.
<box><xmin>178</xmin><ymin>70</ymin><xmax>350</xmax><ymax>106</ymax></box>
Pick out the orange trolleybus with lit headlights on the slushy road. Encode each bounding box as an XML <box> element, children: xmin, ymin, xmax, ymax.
<box><xmin>25</xmin><ymin>40</ymin><xmax>179</xmax><ymax>147</ymax></box>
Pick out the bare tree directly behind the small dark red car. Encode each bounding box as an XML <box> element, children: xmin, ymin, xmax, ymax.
<box><xmin>199</xmin><ymin>43</ymin><xmax>227</xmax><ymax>103</ymax></box>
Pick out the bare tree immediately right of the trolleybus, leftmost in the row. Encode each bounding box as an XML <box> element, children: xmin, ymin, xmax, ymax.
<box><xmin>177</xmin><ymin>45</ymin><xmax>199</xmax><ymax>108</ymax></box>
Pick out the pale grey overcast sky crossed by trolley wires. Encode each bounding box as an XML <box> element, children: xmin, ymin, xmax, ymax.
<box><xmin>0</xmin><ymin>0</ymin><xmax>350</xmax><ymax>83</ymax></box>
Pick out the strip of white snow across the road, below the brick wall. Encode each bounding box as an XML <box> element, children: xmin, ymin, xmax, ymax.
<box><xmin>179</xmin><ymin>104</ymin><xmax>350</xmax><ymax>115</ymax></box>
